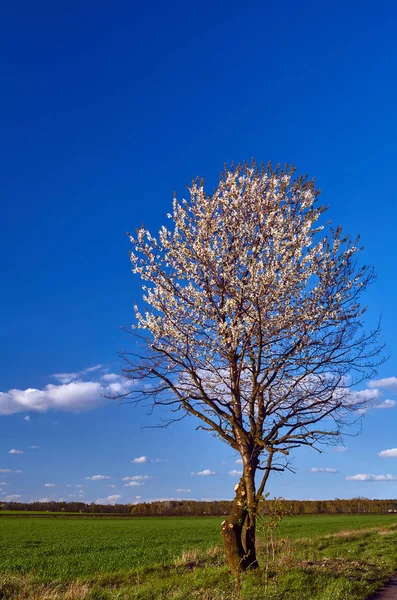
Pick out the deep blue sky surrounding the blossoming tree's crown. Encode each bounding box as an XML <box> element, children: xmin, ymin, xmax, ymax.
<box><xmin>0</xmin><ymin>1</ymin><xmax>397</xmax><ymax>502</ymax></box>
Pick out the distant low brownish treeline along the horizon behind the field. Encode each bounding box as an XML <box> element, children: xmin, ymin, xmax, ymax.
<box><xmin>0</xmin><ymin>498</ymin><xmax>397</xmax><ymax>517</ymax></box>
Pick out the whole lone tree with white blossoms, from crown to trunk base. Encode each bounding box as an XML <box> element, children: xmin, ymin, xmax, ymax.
<box><xmin>120</xmin><ymin>163</ymin><xmax>380</xmax><ymax>573</ymax></box>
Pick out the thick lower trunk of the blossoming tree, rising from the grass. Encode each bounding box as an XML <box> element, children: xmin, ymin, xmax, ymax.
<box><xmin>222</xmin><ymin>477</ymin><xmax>258</xmax><ymax>577</ymax></box>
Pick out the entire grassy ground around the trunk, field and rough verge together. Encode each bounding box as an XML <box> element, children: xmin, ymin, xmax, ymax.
<box><xmin>0</xmin><ymin>515</ymin><xmax>397</xmax><ymax>600</ymax></box>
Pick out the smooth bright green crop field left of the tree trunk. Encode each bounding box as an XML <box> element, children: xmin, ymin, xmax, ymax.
<box><xmin>0</xmin><ymin>517</ymin><xmax>221</xmax><ymax>581</ymax></box>
